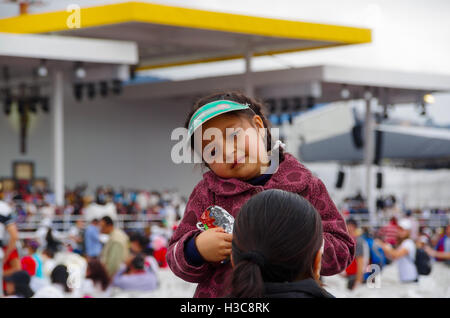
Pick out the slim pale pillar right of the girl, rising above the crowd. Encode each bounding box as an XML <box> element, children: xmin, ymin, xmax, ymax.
<box><xmin>364</xmin><ymin>98</ymin><xmax>376</xmax><ymax>226</ymax></box>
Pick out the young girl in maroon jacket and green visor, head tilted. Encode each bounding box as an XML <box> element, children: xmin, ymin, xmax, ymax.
<box><xmin>167</xmin><ymin>92</ymin><xmax>355</xmax><ymax>297</ymax></box>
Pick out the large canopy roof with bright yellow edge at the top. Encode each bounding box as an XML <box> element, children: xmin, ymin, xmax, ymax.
<box><xmin>0</xmin><ymin>2</ymin><xmax>371</xmax><ymax>69</ymax></box>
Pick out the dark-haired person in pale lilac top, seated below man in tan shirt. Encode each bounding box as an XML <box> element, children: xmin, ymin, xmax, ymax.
<box><xmin>112</xmin><ymin>254</ymin><xmax>158</xmax><ymax>291</ymax></box>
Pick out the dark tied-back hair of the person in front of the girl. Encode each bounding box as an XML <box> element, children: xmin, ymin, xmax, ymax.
<box><xmin>231</xmin><ymin>189</ymin><xmax>323</xmax><ymax>298</ymax></box>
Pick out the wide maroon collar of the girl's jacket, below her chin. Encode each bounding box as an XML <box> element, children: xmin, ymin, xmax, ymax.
<box><xmin>203</xmin><ymin>153</ymin><xmax>313</xmax><ymax>196</ymax></box>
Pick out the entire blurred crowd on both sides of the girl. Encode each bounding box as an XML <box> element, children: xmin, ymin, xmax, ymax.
<box><xmin>0</xmin><ymin>186</ymin><xmax>450</xmax><ymax>298</ymax></box>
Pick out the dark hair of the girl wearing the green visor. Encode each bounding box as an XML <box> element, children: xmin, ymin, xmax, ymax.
<box><xmin>184</xmin><ymin>91</ymin><xmax>284</xmax><ymax>162</ymax></box>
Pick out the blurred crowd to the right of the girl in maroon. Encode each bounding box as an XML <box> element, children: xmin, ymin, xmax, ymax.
<box><xmin>342</xmin><ymin>211</ymin><xmax>450</xmax><ymax>290</ymax></box>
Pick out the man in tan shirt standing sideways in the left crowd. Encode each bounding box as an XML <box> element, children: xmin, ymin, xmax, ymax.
<box><xmin>100</xmin><ymin>216</ymin><xmax>129</xmax><ymax>277</ymax></box>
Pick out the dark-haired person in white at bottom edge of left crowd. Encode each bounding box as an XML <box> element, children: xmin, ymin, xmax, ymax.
<box><xmin>33</xmin><ymin>264</ymin><xmax>72</xmax><ymax>298</ymax></box>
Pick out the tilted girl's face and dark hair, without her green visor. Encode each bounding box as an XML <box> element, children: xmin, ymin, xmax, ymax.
<box><xmin>185</xmin><ymin>92</ymin><xmax>282</xmax><ymax>180</ymax></box>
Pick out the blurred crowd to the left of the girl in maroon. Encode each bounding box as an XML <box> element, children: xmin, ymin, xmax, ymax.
<box><xmin>0</xmin><ymin>186</ymin><xmax>186</xmax><ymax>298</ymax></box>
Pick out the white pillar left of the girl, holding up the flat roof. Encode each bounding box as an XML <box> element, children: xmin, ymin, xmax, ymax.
<box><xmin>52</xmin><ymin>70</ymin><xmax>64</xmax><ymax>206</ymax></box>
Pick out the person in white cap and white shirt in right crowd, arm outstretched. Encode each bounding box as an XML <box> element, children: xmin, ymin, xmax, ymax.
<box><xmin>376</xmin><ymin>219</ymin><xmax>419</xmax><ymax>283</ymax></box>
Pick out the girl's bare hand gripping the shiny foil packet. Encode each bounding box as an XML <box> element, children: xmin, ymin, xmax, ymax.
<box><xmin>195</xmin><ymin>227</ymin><xmax>233</xmax><ymax>262</ymax></box>
